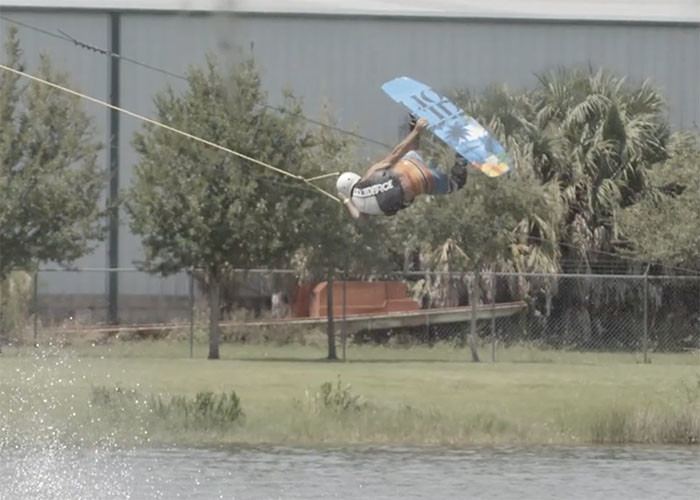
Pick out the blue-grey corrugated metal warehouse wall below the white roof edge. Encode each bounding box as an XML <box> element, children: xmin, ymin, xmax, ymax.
<box><xmin>0</xmin><ymin>10</ymin><xmax>700</xmax><ymax>300</ymax></box>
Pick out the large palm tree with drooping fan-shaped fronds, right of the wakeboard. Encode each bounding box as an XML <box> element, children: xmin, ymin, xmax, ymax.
<box><xmin>518</xmin><ymin>70</ymin><xmax>669</xmax><ymax>272</ymax></box>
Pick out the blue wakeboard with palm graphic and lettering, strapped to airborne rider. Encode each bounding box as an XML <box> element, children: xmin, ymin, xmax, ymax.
<box><xmin>382</xmin><ymin>76</ymin><xmax>510</xmax><ymax>177</ymax></box>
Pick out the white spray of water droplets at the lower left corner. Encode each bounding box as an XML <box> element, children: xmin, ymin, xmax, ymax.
<box><xmin>0</xmin><ymin>347</ymin><xmax>161</xmax><ymax>500</ymax></box>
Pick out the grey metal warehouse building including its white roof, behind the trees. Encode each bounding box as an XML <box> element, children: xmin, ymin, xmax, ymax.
<box><xmin>0</xmin><ymin>0</ymin><xmax>700</xmax><ymax>320</ymax></box>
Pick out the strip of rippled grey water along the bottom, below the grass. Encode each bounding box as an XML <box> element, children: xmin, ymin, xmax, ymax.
<box><xmin>0</xmin><ymin>447</ymin><xmax>700</xmax><ymax>500</ymax></box>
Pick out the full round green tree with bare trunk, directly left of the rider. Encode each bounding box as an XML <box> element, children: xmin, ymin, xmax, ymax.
<box><xmin>126</xmin><ymin>57</ymin><xmax>320</xmax><ymax>359</ymax></box>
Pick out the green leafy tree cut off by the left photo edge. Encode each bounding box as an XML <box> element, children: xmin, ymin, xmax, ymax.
<box><xmin>0</xmin><ymin>29</ymin><xmax>106</xmax><ymax>281</ymax></box>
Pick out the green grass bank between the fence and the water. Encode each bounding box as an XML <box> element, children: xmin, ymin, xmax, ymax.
<box><xmin>0</xmin><ymin>342</ymin><xmax>700</xmax><ymax>447</ymax></box>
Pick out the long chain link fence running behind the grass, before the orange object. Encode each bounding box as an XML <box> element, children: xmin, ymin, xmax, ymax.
<box><xmin>0</xmin><ymin>269</ymin><xmax>700</xmax><ymax>362</ymax></box>
